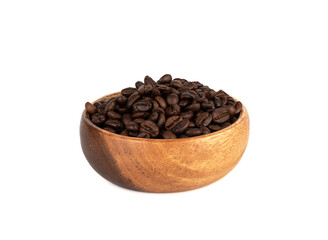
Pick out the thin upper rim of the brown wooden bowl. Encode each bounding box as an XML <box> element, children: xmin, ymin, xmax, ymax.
<box><xmin>82</xmin><ymin>92</ymin><xmax>248</xmax><ymax>143</ymax></box>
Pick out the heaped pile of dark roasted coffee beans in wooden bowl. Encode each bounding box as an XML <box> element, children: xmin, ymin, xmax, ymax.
<box><xmin>85</xmin><ymin>74</ymin><xmax>242</xmax><ymax>139</ymax></box>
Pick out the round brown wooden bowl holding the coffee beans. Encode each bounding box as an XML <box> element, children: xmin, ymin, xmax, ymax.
<box><xmin>80</xmin><ymin>93</ymin><xmax>249</xmax><ymax>193</ymax></box>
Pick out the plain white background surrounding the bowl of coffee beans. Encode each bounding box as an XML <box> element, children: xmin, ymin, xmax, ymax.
<box><xmin>0</xmin><ymin>0</ymin><xmax>328</xmax><ymax>240</ymax></box>
